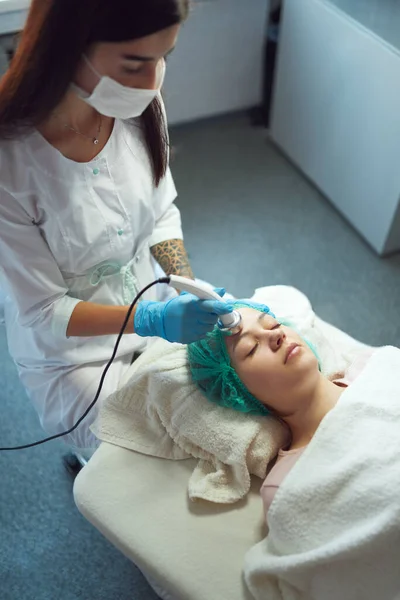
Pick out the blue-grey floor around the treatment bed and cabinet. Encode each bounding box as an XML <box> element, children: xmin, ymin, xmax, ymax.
<box><xmin>0</xmin><ymin>117</ymin><xmax>400</xmax><ymax>600</ymax></box>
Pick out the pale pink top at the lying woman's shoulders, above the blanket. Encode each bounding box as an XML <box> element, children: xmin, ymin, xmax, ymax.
<box><xmin>260</xmin><ymin>350</ymin><xmax>374</xmax><ymax>519</ymax></box>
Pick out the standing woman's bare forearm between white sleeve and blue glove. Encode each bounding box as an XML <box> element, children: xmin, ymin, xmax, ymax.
<box><xmin>67</xmin><ymin>302</ymin><xmax>136</xmax><ymax>337</ymax></box>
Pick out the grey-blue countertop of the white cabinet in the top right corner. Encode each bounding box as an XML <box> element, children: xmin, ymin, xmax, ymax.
<box><xmin>325</xmin><ymin>0</ymin><xmax>400</xmax><ymax>50</ymax></box>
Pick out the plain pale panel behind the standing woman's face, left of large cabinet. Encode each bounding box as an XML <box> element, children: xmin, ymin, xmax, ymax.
<box><xmin>164</xmin><ymin>0</ymin><xmax>269</xmax><ymax>124</ymax></box>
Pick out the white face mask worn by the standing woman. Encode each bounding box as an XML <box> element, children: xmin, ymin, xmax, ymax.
<box><xmin>72</xmin><ymin>55</ymin><xmax>165</xmax><ymax>119</ymax></box>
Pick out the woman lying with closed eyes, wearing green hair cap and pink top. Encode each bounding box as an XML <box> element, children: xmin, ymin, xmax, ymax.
<box><xmin>188</xmin><ymin>303</ymin><xmax>373</xmax><ymax>517</ymax></box>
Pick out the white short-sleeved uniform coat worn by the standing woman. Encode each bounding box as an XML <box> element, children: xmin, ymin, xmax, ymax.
<box><xmin>0</xmin><ymin>120</ymin><xmax>182</xmax><ymax>447</ymax></box>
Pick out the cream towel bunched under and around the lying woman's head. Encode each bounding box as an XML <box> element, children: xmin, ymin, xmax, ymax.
<box><xmin>92</xmin><ymin>286</ymin><xmax>370</xmax><ymax>503</ymax></box>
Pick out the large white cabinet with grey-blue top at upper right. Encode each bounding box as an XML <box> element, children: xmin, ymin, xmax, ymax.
<box><xmin>271</xmin><ymin>0</ymin><xmax>400</xmax><ymax>254</ymax></box>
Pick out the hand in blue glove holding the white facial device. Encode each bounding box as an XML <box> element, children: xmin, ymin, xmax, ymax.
<box><xmin>134</xmin><ymin>289</ymin><xmax>233</xmax><ymax>344</ymax></box>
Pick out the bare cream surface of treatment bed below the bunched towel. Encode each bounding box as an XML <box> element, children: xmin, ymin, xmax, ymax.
<box><xmin>74</xmin><ymin>443</ymin><xmax>265</xmax><ymax>600</ymax></box>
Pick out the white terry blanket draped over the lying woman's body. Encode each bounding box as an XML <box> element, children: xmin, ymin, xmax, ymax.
<box><xmin>245</xmin><ymin>347</ymin><xmax>400</xmax><ymax>600</ymax></box>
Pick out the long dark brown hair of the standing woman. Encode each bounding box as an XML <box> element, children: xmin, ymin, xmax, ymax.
<box><xmin>0</xmin><ymin>0</ymin><xmax>189</xmax><ymax>185</ymax></box>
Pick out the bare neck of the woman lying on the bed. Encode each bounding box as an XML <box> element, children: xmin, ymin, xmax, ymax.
<box><xmin>284</xmin><ymin>375</ymin><xmax>344</xmax><ymax>449</ymax></box>
